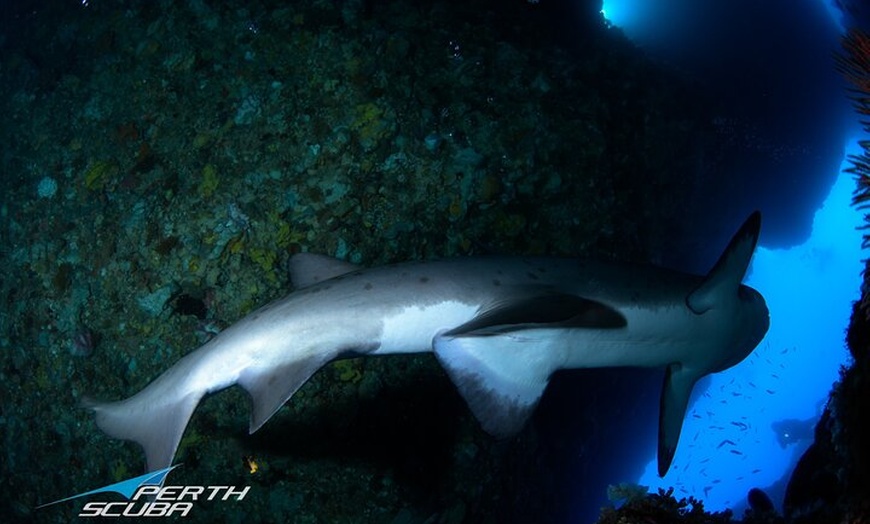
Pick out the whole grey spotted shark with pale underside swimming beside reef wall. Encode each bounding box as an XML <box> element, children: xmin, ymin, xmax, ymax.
<box><xmin>82</xmin><ymin>212</ymin><xmax>769</xmax><ymax>476</ymax></box>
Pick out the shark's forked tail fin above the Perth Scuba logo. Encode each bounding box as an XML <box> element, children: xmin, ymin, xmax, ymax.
<box><xmin>82</xmin><ymin>387</ymin><xmax>204</xmax><ymax>471</ymax></box>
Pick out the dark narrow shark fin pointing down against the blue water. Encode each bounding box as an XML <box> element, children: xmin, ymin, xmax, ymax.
<box><xmin>658</xmin><ymin>364</ymin><xmax>700</xmax><ymax>477</ymax></box>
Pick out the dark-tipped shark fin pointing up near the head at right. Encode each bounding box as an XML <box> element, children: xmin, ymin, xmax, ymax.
<box><xmin>686</xmin><ymin>211</ymin><xmax>761</xmax><ymax>315</ymax></box>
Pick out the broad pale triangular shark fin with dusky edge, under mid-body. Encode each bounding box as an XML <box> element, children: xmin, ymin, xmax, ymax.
<box><xmin>432</xmin><ymin>334</ymin><xmax>553</xmax><ymax>438</ymax></box>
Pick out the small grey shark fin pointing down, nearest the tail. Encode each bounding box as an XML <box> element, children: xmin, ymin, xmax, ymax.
<box><xmin>239</xmin><ymin>355</ymin><xmax>333</xmax><ymax>433</ymax></box>
